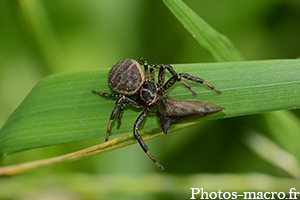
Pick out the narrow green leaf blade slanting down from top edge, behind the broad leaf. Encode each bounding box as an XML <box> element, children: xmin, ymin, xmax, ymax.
<box><xmin>164</xmin><ymin>0</ymin><xmax>243</xmax><ymax>62</ymax></box>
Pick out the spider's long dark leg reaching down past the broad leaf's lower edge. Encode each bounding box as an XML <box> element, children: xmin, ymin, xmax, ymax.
<box><xmin>133</xmin><ymin>107</ymin><xmax>164</xmax><ymax>170</ymax></box>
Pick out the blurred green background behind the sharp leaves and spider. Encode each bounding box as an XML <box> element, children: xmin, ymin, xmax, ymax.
<box><xmin>0</xmin><ymin>0</ymin><xmax>300</xmax><ymax>199</ymax></box>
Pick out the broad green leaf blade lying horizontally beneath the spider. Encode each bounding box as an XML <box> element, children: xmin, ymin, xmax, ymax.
<box><xmin>0</xmin><ymin>60</ymin><xmax>300</xmax><ymax>159</ymax></box>
